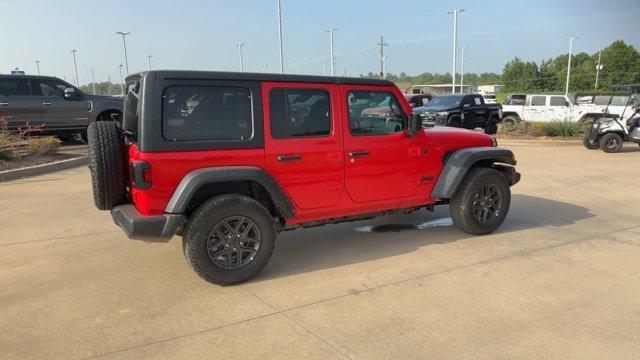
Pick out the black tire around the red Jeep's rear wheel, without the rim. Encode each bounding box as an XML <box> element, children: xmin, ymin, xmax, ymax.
<box><xmin>182</xmin><ymin>194</ymin><xmax>276</xmax><ymax>285</ymax></box>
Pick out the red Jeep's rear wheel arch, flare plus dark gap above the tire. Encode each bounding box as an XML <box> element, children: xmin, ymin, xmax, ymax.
<box><xmin>165</xmin><ymin>166</ymin><xmax>295</xmax><ymax>218</ymax></box>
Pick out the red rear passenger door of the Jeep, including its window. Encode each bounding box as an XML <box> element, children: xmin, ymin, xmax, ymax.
<box><xmin>262</xmin><ymin>82</ymin><xmax>343</xmax><ymax>210</ymax></box>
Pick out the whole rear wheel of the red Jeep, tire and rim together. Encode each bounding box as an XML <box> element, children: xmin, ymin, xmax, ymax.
<box><xmin>182</xmin><ymin>195</ymin><xmax>276</xmax><ymax>285</ymax></box>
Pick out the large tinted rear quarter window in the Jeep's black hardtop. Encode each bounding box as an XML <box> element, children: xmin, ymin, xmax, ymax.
<box><xmin>162</xmin><ymin>86</ymin><xmax>253</xmax><ymax>141</ymax></box>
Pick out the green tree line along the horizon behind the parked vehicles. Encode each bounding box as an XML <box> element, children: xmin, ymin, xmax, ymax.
<box><xmin>360</xmin><ymin>40</ymin><xmax>640</xmax><ymax>93</ymax></box>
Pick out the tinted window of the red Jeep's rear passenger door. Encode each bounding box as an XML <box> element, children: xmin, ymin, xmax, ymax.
<box><xmin>269</xmin><ymin>89</ymin><xmax>331</xmax><ymax>139</ymax></box>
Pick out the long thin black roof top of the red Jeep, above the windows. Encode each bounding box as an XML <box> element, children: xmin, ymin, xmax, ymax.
<box><xmin>127</xmin><ymin>70</ymin><xmax>395</xmax><ymax>86</ymax></box>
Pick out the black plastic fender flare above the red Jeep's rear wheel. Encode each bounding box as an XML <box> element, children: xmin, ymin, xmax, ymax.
<box><xmin>164</xmin><ymin>166</ymin><xmax>295</xmax><ymax>218</ymax></box>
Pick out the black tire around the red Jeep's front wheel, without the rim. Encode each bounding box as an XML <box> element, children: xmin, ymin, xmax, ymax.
<box><xmin>449</xmin><ymin>167</ymin><xmax>511</xmax><ymax>235</ymax></box>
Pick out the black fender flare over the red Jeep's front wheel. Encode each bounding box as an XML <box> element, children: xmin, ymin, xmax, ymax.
<box><xmin>431</xmin><ymin>147</ymin><xmax>519</xmax><ymax>199</ymax></box>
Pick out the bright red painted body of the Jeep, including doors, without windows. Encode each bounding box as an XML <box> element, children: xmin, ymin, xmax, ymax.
<box><xmin>128</xmin><ymin>82</ymin><xmax>491</xmax><ymax>225</ymax></box>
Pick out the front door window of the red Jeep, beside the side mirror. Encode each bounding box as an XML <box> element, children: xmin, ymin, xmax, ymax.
<box><xmin>347</xmin><ymin>91</ymin><xmax>406</xmax><ymax>135</ymax></box>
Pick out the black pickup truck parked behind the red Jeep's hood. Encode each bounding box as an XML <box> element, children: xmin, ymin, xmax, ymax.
<box><xmin>413</xmin><ymin>94</ymin><xmax>502</xmax><ymax>134</ymax></box>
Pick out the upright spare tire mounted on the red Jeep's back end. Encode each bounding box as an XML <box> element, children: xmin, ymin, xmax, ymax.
<box><xmin>87</xmin><ymin>121</ymin><xmax>126</xmax><ymax>210</ymax></box>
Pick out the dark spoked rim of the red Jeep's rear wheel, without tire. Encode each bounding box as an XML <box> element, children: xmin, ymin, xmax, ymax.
<box><xmin>207</xmin><ymin>216</ymin><xmax>261</xmax><ymax>269</ymax></box>
